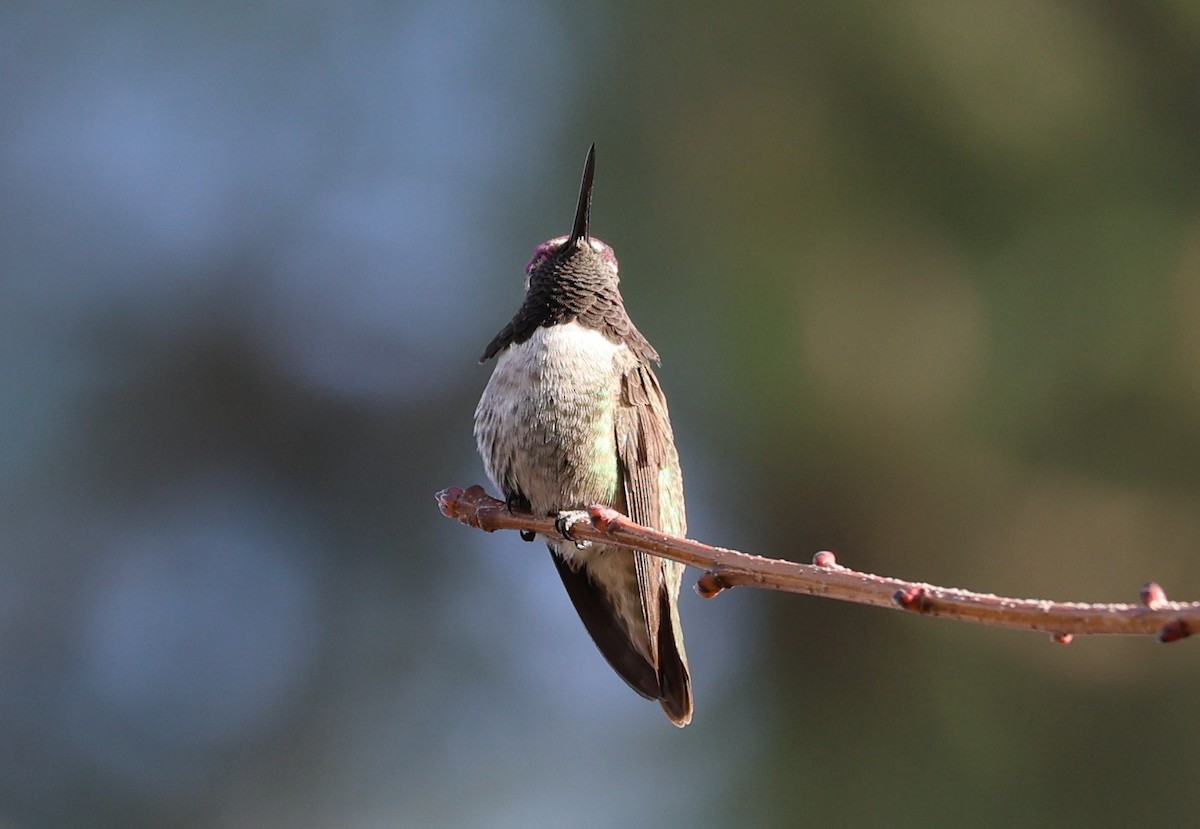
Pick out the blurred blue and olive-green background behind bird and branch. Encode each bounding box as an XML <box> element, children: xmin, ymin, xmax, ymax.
<box><xmin>0</xmin><ymin>0</ymin><xmax>1200</xmax><ymax>829</ymax></box>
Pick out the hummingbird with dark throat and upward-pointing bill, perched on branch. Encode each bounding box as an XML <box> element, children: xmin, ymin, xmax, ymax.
<box><xmin>475</xmin><ymin>144</ymin><xmax>692</xmax><ymax>727</ymax></box>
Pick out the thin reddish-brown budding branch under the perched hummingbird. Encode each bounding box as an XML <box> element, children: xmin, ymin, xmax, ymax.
<box><xmin>437</xmin><ymin>486</ymin><xmax>1200</xmax><ymax>643</ymax></box>
